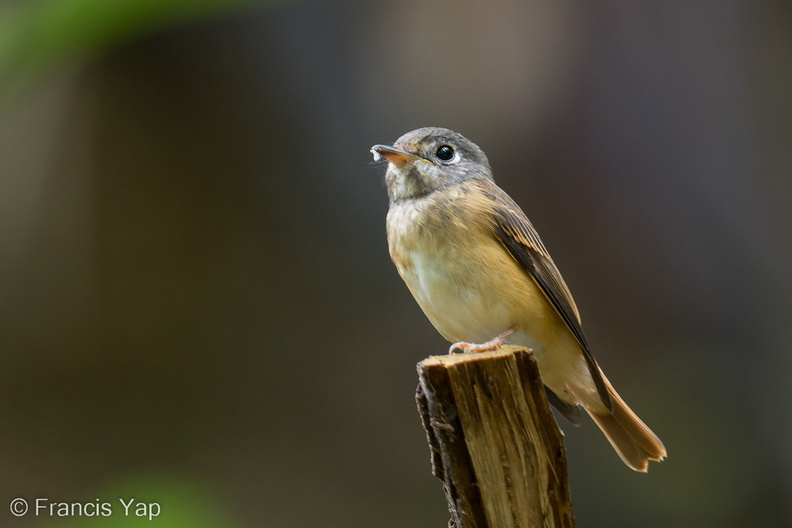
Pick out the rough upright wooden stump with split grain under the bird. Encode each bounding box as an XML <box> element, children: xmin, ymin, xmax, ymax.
<box><xmin>416</xmin><ymin>346</ymin><xmax>574</xmax><ymax>528</ymax></box>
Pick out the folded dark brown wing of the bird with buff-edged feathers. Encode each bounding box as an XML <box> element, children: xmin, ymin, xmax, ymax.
<box><xmin>476</xmin><ymin>182</ymin><xmax>612</xmax><ymax>410</ymax></box>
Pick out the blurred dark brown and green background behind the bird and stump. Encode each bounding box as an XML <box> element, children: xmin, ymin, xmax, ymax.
<box><xmin>0</xmin><ymin>0</ymin><xmax>792</xmax><ymax>528</ymax></box>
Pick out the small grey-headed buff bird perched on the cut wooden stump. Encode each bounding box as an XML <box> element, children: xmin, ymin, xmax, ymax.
<box><xmin>371</xmin><ymin>127</ymin><xmax>666</xmax><ymax>472</ymax></box>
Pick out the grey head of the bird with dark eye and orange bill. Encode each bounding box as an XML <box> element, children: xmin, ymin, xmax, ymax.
<box><xmin>371</xmin><ymin>127</ymin><xmax>492</xmax><ymax>202</ymax></box>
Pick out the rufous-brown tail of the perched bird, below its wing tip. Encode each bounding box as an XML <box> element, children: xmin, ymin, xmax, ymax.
<box><xmin>586</xmin><ymin>371</ymin><xmax>666</xmax><ymax>473</ymax></box>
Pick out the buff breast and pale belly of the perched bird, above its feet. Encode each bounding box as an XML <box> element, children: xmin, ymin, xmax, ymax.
<box><xmin>387</xmin><ymin>195</ymin><xmax>546</xmax><ymax>343</ymax></box>
